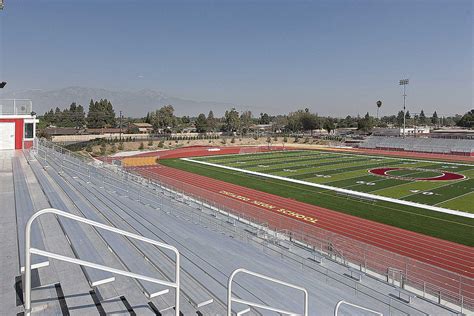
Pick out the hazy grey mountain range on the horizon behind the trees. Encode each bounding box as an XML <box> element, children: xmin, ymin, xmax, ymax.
<box><xmin>0</xmin><ymin>87</ymin><xmax>235</xmax><ymax>117</ymax></box>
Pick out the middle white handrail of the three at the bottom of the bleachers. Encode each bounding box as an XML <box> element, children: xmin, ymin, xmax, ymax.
<box><xmin>227</xmin><ymin>268</ymin><xmax>308</xmax><ymax>316</ymax></box>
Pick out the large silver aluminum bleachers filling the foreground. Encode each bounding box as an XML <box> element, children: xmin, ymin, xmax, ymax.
<box><xmin>0</xmin><ymin>144</ymin><xmax>468</xmax><ymax>316</ymax></box>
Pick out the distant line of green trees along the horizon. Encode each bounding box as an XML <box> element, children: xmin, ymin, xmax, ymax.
<box><xmin>40</xmin><ymin>99</ymin><xmax>474</xmax><ymax>136</ymax></box>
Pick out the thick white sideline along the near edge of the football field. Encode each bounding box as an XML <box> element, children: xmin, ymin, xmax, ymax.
<box><xmin>181</xmin><ymin>158</ymin><xmax>474</xmax><ymax>218</ymax></box>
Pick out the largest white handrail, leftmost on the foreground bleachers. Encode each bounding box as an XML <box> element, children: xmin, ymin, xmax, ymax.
<box><xmin>25</xmin><ymin>208</ymin><xmax>180</xmax><ymax>316</ymax></box>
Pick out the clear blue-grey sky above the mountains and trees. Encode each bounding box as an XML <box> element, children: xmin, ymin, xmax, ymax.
<box><xmin>0</xmin><ymin>0</ymin><xmax>474</xmax><ymax>116</ymax></box>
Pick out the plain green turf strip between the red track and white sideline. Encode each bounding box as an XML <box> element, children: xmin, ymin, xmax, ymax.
<box><xmin>160</xmin><ymin>155</ymin><xmax>474</xmax><ymax>246</ymax></box>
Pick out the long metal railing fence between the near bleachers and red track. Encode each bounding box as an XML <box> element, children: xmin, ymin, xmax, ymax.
<box><xmin>31</xmin><ymin>140</ymin><xmax>474</xmax><ymax>312</ymax></box>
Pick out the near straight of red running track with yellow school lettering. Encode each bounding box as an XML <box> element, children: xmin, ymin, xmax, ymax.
<box><xmin>136</xmin><ymin>166</ymin><xmax>474</xmax><ymax>300</ymax></box>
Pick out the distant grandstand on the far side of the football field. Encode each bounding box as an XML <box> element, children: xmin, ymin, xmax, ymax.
<box><xmin>358</xmin><ymin>136</ymin><xmax>474</xmax><ymax>156</ymax></box>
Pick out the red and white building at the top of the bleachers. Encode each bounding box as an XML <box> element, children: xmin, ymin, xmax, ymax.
<box><xmin>0</xmin><ymin>99</ymin><xmax>38</xmax><ymax>150</ymax></box>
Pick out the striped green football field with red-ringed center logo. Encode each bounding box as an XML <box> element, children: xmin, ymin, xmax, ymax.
<box><xmin>186</xmin><ymin>150</ymin><xmax>474</xmax><ymax>213</ymax></box>
